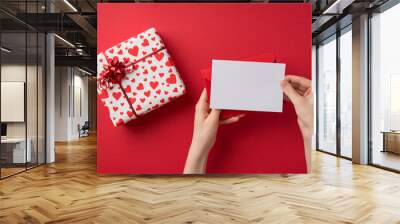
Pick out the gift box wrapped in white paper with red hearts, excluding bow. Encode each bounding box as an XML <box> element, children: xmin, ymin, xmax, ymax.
<box><xmin>97</xmin><ymin>28</ymin><xmax>186</xmax><ymax>126</ymax></box>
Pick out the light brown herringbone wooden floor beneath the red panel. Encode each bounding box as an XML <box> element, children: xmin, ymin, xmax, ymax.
<box><xmin>0</xmin><ymin>134</ymin><xmax>400</xmax><ymax>224</ymax></box>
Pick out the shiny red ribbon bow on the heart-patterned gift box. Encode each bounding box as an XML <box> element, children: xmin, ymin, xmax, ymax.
<box><xmin>97</xmin><ymin>58</ymin><xmax>131</xmax><ymax>89</ymax></box>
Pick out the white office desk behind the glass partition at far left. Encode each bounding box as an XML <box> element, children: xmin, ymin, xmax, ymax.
<box><xmin>1</xmin><ymin>138</ymin><xmax>32</xmax><ymax>163</ymax></box>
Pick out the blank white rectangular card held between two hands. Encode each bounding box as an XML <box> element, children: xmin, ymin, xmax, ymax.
<box><xmin>210</xmin><ymin>60</ymin><xmax>285</xmax><ymax>112</ymax></box>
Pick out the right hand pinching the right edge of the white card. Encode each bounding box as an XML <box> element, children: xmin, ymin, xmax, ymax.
<box><xmin>281</xmin><ymin>75</ymin><xmax>314</xmax><ymax>171</ymax></box>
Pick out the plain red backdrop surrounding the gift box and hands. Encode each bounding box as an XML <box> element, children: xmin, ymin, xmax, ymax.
<box><xmin>97</xmin><ymin>3</ymin><xmax>311</xmax><ymax>174</ymax></box>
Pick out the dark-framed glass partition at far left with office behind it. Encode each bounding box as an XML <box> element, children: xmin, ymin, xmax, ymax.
<box><xmin>0</xmin><ymin>0</ymin><xmax>46</xmax><ymax>178</ymax></box>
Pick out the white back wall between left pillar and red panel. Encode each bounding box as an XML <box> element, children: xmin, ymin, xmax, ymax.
<box><xmin>55</xmin><ymin>67</ymin><xmax>88</xmax><ymax>141</ymax></box>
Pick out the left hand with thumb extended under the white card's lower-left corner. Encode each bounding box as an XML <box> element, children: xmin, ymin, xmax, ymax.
<box><xmin>183</xmin><ymin>89</ymin><xmax>243</xmax><ymax>174</ymax></box>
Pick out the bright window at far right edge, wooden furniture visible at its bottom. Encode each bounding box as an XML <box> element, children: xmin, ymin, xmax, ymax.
<box><xmin>370</xmin><ymin>4</ymin><xmax>400</xmax><ymax>170</ymax></box>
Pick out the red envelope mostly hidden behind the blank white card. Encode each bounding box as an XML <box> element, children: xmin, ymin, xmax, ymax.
<box><xmin>201</xmin><ymin>54</ymin><xmax>277</xmax><ymax>120</ymax></box>
